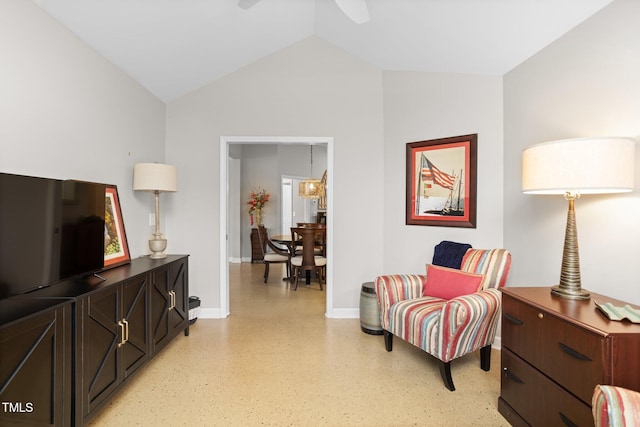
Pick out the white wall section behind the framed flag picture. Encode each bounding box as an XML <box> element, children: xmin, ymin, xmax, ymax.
<box><xmin>380</xmin><ymin>72</ymin><xmax>503</xmax><ymax>274</ymax></box>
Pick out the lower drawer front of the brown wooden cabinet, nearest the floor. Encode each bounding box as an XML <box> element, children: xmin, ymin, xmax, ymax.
<box><xmin>500</xmin><ymin>349</ymin><xmax>593</xmax><ymax>426</ymax></box>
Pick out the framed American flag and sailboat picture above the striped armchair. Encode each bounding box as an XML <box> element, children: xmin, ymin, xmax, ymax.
<box><xmin>406</xmin><ymin>134</ymin><xmax>478</xmax><ymax>228</ymax></box>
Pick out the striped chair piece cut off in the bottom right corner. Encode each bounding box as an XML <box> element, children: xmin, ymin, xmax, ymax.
<box><xmin>592</xmin><ymin>385</ymin><xmax>640</xmax><ymax>427</ymax></box>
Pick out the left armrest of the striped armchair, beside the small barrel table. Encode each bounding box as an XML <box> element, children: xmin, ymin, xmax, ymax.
<box><xmin>375</xmin><ymin>274</ymin><xmax>427</xmax><ymax>330</ymax></box>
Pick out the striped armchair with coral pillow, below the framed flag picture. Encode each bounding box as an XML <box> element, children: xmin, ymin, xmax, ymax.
<box><xmin>375</xmin><ymin>249</ymin><xmax>511</xmax><ymax>391</ymax></box>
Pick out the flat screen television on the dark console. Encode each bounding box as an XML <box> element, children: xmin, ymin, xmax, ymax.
<box><xmin>0</xmin><ymin>173</ymin><xmax>105</xmax><ymax>298</ymax></box>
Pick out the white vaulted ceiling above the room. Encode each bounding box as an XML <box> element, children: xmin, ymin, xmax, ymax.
<box><xmin>33</xmin><ymin>0</ymin><xmax>613</xmax><ymax>101</ymax></box>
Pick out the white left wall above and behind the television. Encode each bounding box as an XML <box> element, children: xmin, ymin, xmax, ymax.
<box><xmin>0</xmin><ymin>0</ymin><xmax>166</xmax><ymax>257</ymax></box>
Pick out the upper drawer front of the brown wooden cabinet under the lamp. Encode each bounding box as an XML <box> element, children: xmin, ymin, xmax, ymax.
<box><xmin>502</xmin><ymin>297</ymin><xmax>609</xmax><ymax>403</ymax></box>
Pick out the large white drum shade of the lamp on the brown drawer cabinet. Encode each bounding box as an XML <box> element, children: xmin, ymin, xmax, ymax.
<box><xmin>522</xmin><ymin>137</ymin><xmax>635</xmax><ymax>194</ymax></box>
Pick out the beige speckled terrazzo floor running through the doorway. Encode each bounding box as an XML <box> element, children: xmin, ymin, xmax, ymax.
<box><xmin>89</xmin><ymin>264</ymin><xmax>509</xmax><ymax>427</ymax></box>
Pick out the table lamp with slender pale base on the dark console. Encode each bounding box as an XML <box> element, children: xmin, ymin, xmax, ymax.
<box><xmin>133</xmin><ymin>163</ymin><xmax>178</xmax><ymax>259</ymax></box>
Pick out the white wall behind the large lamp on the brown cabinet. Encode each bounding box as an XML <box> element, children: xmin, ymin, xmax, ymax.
<box><xmin>504</xmin><ymin>0</ymin><xmax>640</xmax><ymax>304</ymax></box>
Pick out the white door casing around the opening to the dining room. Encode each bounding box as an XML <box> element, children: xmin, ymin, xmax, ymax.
<box><xmin>220</xmin><ymin>136</ymin><xmax>334</xmax><ymax>317</ymax></box>
